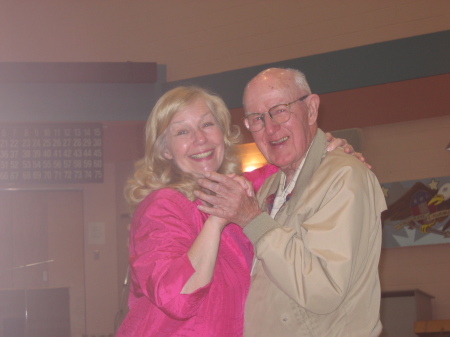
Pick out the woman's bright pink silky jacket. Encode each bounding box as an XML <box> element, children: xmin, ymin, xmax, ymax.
<box><xmin>116</xmin><ymin>165</ymin><xmax>277</xmax><ymax>337</ymax></box>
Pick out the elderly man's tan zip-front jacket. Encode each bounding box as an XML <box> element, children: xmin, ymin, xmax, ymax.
<box><xmin>244</xmin><ymin>129</ymin><xmax>386</xmax><ymax>337</ymax></box>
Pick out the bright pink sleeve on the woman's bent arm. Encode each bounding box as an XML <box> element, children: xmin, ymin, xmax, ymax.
<box><xmin>130</xmin><ymin>189</ymin><xmax>211</xmax><ymax>320</ymax></box>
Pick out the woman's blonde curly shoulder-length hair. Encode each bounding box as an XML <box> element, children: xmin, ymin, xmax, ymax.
<box><xmin>125</xmin><ymin>86</ymin><xmax>242</xmax><ymax>212</ymax></box>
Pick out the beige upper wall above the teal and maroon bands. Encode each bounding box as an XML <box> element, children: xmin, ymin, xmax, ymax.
<box><xmin>0</xmin><ymin>0</ymin><xmax>450</xmax><ymax>81</ymax></box>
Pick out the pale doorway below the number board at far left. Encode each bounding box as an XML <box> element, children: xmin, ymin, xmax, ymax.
<box><xmin>0</xmin><ymin>189</ymin><xmax>86</xmax><ymax>337</ymax></box>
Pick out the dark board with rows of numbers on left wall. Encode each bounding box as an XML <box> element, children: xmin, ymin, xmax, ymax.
<box><xmin>0</xmin><ymin>123</ymin><xmax>103</xmax><ymax>184</ymax></box>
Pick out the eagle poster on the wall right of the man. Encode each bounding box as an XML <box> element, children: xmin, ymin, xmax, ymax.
<box><xmin>381</xmin><ymin>176</ymin><xmax>450</xmax><ymax>248</ymax></box>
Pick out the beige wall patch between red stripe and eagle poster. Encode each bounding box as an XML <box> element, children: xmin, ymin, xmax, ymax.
<box><xmin>363</xmin><ymin>115</ymin><xmax>450</xmax><ymax>184</ymax></box>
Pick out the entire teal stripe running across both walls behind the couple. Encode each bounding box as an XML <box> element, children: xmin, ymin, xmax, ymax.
<box><xmin>0</xmin><ymin>30</ymin><xmax>450</xmax><ymax>122</ymax></box>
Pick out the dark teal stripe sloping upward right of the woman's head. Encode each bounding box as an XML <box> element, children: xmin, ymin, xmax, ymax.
<box><xmin>165</xmin><ymin>30</ymin><xmax>450</xmax><ymax>109</ymax></box>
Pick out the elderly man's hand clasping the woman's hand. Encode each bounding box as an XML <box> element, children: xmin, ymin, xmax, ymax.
<box><xmin>194</xmin><ymin>172</ymin><xmax>262</xmax><ymax>227</ymax></box>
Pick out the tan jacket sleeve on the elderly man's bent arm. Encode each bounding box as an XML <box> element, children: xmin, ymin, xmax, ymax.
<box><xmin>244</xmin><ymin>167</ymin><xmax>385</xmax><ymax>314</ymax></box>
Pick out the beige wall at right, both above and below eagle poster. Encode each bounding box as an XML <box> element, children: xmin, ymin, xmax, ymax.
<box><xmin>363</xmin><ymin>115</ymin><xmax>450</xmax><ymax>320</ymax></box>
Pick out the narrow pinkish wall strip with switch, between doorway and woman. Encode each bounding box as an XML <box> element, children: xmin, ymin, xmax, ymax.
<box><xmin>83</xmin><ymin>163</ymin><xmax>119</xmax><ymax>335</ymax></box>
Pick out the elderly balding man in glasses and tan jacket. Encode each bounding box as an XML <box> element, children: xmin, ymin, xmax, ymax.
<box><xmin>196</xmin><ymin>68</ymin><xmax>386</xmax><ymax>337</ymax></box>
